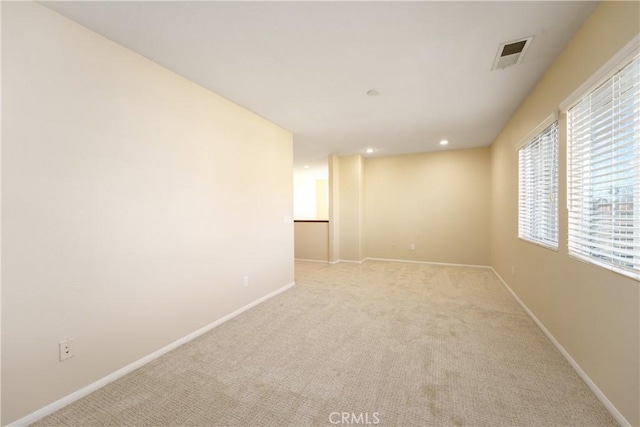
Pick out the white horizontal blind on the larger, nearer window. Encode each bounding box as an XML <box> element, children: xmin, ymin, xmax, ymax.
<box><xmin>567</xmin><ymin>56</ymin><xmax>640</xmax><ymax>279</ymax></box>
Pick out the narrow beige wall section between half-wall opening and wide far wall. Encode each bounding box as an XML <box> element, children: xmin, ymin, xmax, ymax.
<box><xmin>337</xmin><ymin>155</ymin><xmax>364</xmax><ymax>262</ymax></box>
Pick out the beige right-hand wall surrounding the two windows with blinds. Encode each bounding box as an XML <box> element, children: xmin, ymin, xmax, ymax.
<box><xmin>491</xmin><ymin>2</ymin><xmax>640</xmax><ymax>425</ymax></box>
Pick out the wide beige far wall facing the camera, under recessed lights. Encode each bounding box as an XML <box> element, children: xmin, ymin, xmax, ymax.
<box><xmin>364</xmin><ymin>148</ymin><xmax>491</xmax><ymax>265</ymax></box>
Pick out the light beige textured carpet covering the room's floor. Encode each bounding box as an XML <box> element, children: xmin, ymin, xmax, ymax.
<box><xmin>37</xmin><ymin>261</ymin><xmax>617</xmax><ymax>426</ymax></box>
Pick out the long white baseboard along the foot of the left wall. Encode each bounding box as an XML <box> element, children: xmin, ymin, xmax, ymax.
<box><xmin>7</xmin><ymin>282</ymin><xmax>295</xmax><ymax>427</ymax></box>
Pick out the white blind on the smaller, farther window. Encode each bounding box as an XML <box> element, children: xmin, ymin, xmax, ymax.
<box><xmin>518</xmin><ymin>121</ymin><xmax>558</xmax><ymax>249</ymax></box>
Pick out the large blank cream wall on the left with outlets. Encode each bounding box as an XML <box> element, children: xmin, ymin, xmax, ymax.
<box><xmin>2</xmin><ymin>2</ymin><xmax>293</xmax><ymax>424</ymax></box>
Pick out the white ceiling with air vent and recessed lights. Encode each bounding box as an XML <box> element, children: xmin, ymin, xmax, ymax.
<box><xmin>43</xmin><ymin>1</ymin><xmax>596</xmax><ymax>171</ymax></box>
